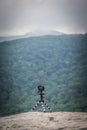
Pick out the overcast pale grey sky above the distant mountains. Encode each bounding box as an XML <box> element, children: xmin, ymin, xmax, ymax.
<box><xmin>0</xmin><ymin>0</ymin><xmax>87</xmax><ymax>35</ymax></box>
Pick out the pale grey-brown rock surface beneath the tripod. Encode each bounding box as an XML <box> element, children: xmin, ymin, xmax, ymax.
<box><xmin>0</xmin><ymin>112</ymin><xmax>87</xmax><ymax>130</ymax></box>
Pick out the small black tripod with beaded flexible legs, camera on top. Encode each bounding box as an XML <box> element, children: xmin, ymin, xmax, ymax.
<box><xmin>32</xmin><ymin>85</ymin><xmax>52</xmax><ymax>112</ymax></box>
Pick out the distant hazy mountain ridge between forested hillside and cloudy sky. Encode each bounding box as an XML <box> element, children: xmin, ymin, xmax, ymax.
<box><xmin>0</xmin><ymin>30</ymin><xmax>87</xmax><ymax>42</ymax></box>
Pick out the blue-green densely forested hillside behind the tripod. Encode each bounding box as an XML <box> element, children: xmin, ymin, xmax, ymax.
<box><xmin>0</xmin><ymin>34</ymin><xmax>87</xmax><ymax>116</ymax></box>
